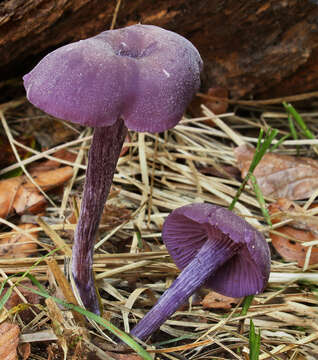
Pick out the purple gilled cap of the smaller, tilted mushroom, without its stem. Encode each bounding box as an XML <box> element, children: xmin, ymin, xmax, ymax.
<box><xmin>162</xmin><ymin>203</ymin><xmax>270</xmax><ymax>297</ymax></box>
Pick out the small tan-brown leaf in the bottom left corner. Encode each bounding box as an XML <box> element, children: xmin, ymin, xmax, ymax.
<box><xmin>0</xmin><ymin>322</ymin><xmax>20</xmax><ymax>360</ymax></box>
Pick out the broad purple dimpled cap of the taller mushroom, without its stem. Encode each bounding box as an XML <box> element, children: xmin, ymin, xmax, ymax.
<box><xmin>23</xmin><ymin>25</ymin><xmax>202</xmax><ymax>132</ymax></box>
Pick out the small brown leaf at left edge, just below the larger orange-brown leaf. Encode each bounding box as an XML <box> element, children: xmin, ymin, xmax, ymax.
<box><xmin>0</xmin><ymin>224</ymin><xmax>38</xmax><ymax>258</ymax></box>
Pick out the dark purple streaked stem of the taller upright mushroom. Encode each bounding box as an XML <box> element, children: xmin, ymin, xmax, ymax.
<box><xmin>72</xmin><ymin>119</ymin><xmax>127</xmax><ymax>314</ymax></box>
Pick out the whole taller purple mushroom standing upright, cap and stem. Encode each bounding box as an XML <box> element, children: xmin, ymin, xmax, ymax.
<box><xmin>24</xmin><ymin>25</ymin><xmax>202</xmax><ymax>313</ymax></box>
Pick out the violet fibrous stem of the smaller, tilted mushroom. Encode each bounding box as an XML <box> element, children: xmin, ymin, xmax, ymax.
<box><xmin>130</xmin><ymin>236</ymin><xmax>240</xmax><ymax>340</ymax></box>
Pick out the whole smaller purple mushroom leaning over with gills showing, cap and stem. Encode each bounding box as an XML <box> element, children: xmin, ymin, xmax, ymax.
<box><xmin>131</xmin><ymin>204</ymin><xmax>270</xmax><ymax>340</ymax></box>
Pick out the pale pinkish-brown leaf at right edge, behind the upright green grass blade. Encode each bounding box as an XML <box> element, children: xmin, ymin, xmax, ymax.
<box><xmin>234</xmin><ymin>145</ymin><xmax>318</xmax><ymax>200</ymax></box>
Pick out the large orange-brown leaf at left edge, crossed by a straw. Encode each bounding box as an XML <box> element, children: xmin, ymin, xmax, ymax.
<box><xmin>0</xmin><ymin>166</ymin><xmax>73</xmax><ymax>218</ymax></box>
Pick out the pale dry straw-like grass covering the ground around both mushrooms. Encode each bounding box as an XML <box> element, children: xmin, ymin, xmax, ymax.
<box><xmin>0</xmin><ymin>96</ymin><xmax>318</xmax><ymax>360</ymax></box>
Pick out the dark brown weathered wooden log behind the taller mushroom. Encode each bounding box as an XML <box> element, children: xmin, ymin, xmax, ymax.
<box><xmin>0</xmin><ymin>0</ymin><xmax>318</xmax><ymax>98</ymax></box>
